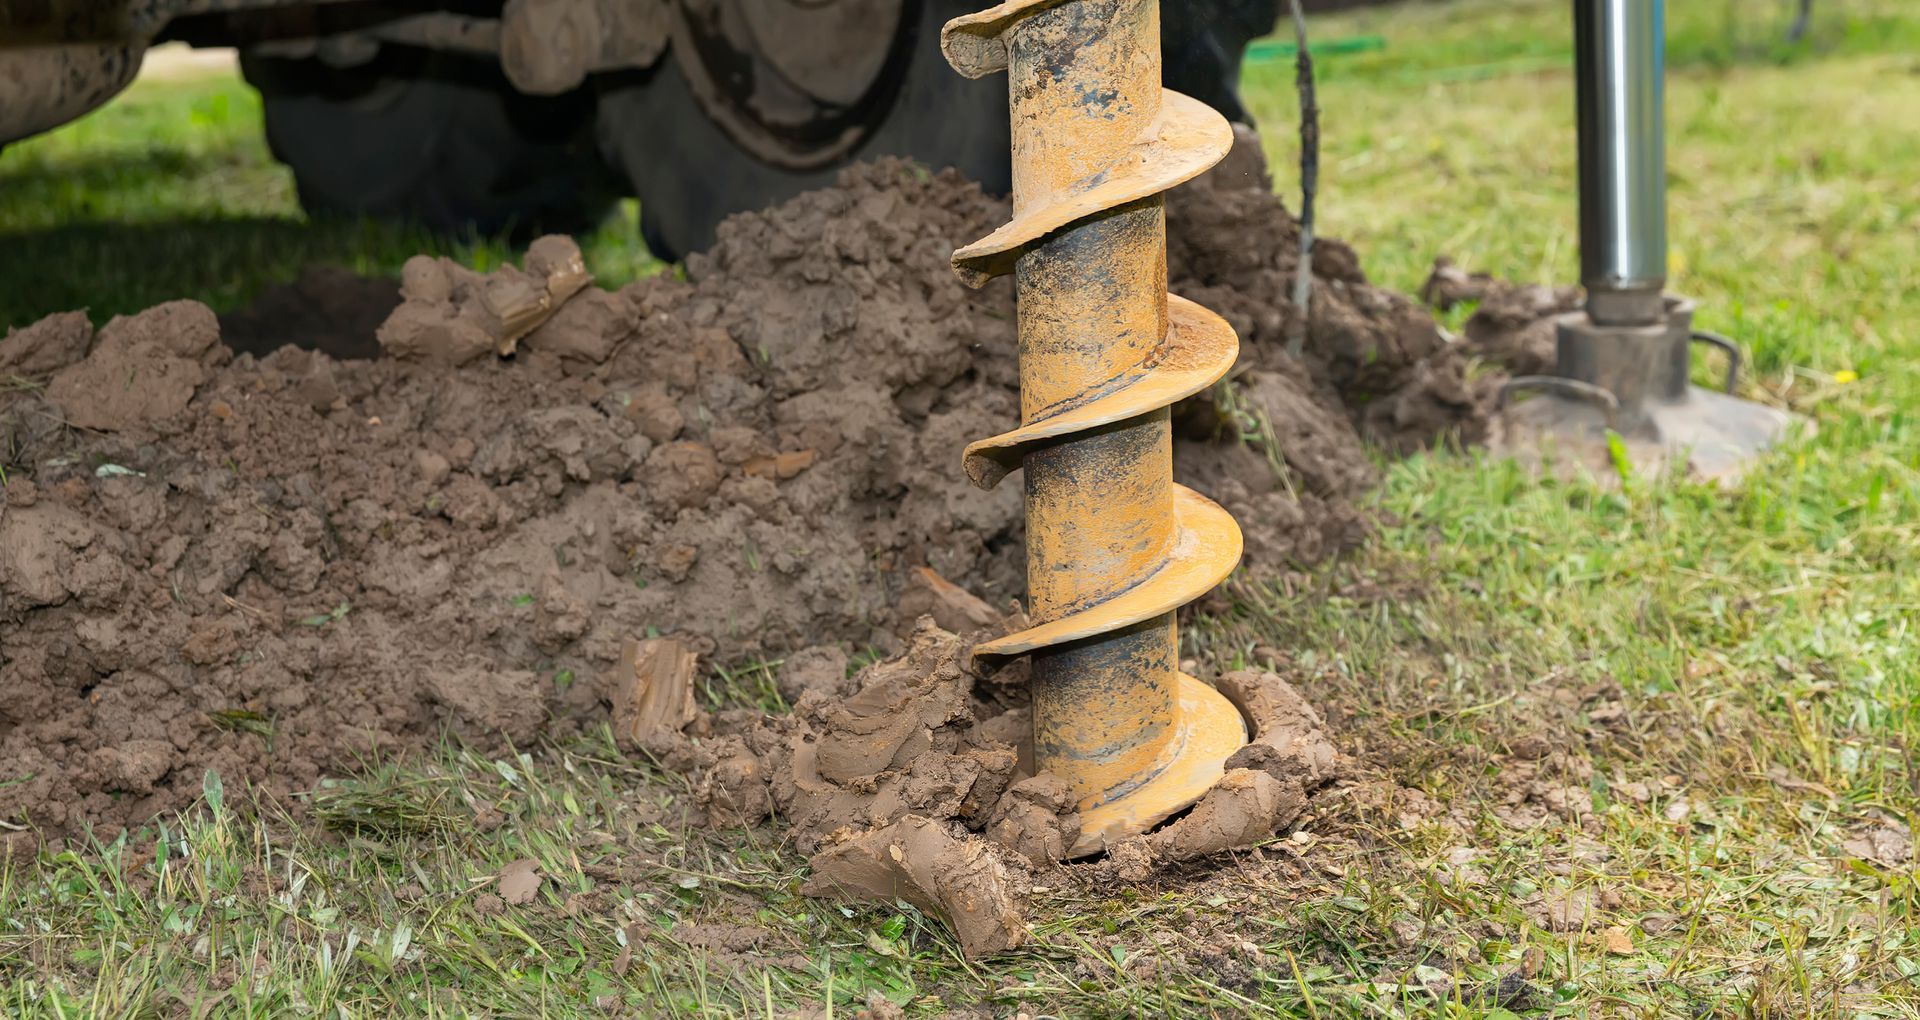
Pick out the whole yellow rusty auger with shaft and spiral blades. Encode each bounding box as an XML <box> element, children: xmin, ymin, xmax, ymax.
<box><xmin>943</xmin><ymin>0</ymin><xmax>1246</xmax><ymax>855</ymax></box>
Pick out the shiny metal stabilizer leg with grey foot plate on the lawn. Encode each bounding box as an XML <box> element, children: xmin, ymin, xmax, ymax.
<box><xmin>1503</xmin><ymin>0</ymin><xmax>1791</xmax><ymax>478</ymax></box>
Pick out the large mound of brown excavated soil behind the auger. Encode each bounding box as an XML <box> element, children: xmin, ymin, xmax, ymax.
<box><xmin>0</xmin><ymin>131</ymin><xmax>1480</xmax><ymax>839</ymax></box>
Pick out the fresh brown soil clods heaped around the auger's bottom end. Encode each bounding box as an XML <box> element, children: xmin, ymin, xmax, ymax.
<box><xmin>624</xmin><ymin>619</ymin><xmax>1336</xmax><ymax>957</ymax></box>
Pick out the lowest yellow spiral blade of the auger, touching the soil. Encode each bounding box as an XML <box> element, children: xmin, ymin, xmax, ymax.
<box><xmin>1068</xmin><ymin>672</ymin><xmax>1246</xmax><ymax>857</ymax></box>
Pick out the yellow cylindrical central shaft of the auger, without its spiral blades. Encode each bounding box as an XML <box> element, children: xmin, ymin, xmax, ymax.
<box><xmin>1008</xmin><ymin>0</ymin><xmax>1179</xmax><ymax>814</ymax></box>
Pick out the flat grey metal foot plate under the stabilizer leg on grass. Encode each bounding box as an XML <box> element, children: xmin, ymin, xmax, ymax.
<box><xmin>1488</xmin><ymin>386</ymin><xmax>1805</xmax><ymax>482</ymax></box>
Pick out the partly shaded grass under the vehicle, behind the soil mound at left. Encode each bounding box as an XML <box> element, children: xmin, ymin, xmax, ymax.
<box><xmin>0</xmin><ymin>75</ymin><xmax>660</xmax><ymax>327</ymax></box>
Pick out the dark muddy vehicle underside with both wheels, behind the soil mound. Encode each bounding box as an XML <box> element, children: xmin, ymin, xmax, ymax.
<box><xmin>0</xmin><ymin>0</ymin><xmax>1279</xmax><ymax>257</ymax></box>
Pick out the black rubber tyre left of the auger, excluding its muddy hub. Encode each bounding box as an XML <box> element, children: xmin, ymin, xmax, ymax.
<box><xmin>599</xmin><ymin>0</ymin><xmax>1012</xmax><ymax>261</ymax></box>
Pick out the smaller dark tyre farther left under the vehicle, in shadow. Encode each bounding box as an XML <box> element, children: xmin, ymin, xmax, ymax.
<box><xmin>240</xmin><ymin>46</ymin><xmax>618</xmax><ymax>238</ymax></box>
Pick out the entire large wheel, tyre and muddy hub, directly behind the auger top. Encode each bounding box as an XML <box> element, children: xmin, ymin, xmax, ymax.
<box><xmin>601</xmin><ymin>0</ymin><xmax>1279</xmax><ymax>257</ymax></box>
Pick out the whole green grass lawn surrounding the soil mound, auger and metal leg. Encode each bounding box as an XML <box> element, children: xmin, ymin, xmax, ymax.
<box><xmin>0</xmin><ymin>0</ymin><xmax>1920</xmax><ymax>1018</ymax></box>
